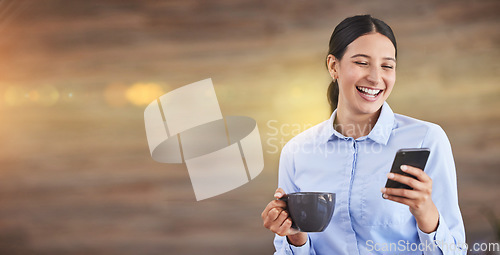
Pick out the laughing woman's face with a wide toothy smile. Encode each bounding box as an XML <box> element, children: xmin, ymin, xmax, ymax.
<box><xmin>329</xmin><ymin>33</ymin><xmax>396</xmax><ymax>114</ymax></box>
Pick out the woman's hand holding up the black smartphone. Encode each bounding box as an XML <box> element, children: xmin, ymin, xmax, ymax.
<box><xmin>382</xmin><ymin>165</ymin><xmax>439</xmax><ymax>233</ymax></box>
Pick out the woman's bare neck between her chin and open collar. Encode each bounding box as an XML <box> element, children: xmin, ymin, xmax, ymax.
<box><xmin>333</xmin><ymin>108</ymin><xmax>381</xmax><ymax>139</ymax></box>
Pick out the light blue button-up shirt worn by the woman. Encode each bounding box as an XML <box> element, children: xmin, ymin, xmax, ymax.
<box><xmin>274</xmin><ymin>103</ymin><xmax>466</xmax><ymax>255</ymax></box>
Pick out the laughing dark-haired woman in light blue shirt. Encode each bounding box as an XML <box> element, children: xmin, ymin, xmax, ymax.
<box><xmin>262</xmin><ymin>15</ymin><xmax>466</xmax><ymax>254</ymax></box>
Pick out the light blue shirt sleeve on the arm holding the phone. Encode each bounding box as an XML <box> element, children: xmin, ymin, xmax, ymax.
<box><xmin>417</xmin><ymin>125</ymin><xmax>467</xmax><ymax>255</ymax></box>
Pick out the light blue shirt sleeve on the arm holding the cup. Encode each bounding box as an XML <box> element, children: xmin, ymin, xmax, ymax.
<box><xmin>274</xmin><ymin>143</ymin><xmax>316</xmax><ymax>255</ymax></box>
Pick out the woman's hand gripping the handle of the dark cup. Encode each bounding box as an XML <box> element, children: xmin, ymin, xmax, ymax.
<box><xmin>261</xmin><ymin>188</ymin><xmax>307</xmax><ymax>246</ymax></box>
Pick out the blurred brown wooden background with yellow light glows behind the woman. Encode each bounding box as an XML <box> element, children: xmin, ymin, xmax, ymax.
<box><xmin>0</xmin><ymin>0</ymin><xmax>500</xmax><ymax>254</ymax></box>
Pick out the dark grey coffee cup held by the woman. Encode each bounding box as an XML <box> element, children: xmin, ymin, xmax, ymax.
<box><xmin>280</xmin><ymin>192</ymin><xmax>335</xmax><ymax>232</ymax></box>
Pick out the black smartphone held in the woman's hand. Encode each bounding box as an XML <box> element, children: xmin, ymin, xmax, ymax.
<box><xmin>385</xmin><ymin>148</ymin><xmax>431</xmax><ymax>189</ymax></box>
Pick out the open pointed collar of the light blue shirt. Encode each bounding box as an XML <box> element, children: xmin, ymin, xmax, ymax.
<box><xmin>324</xmin><ymin>102</ymin><xmax>395</xmax><ymax>145</ymax></box>
